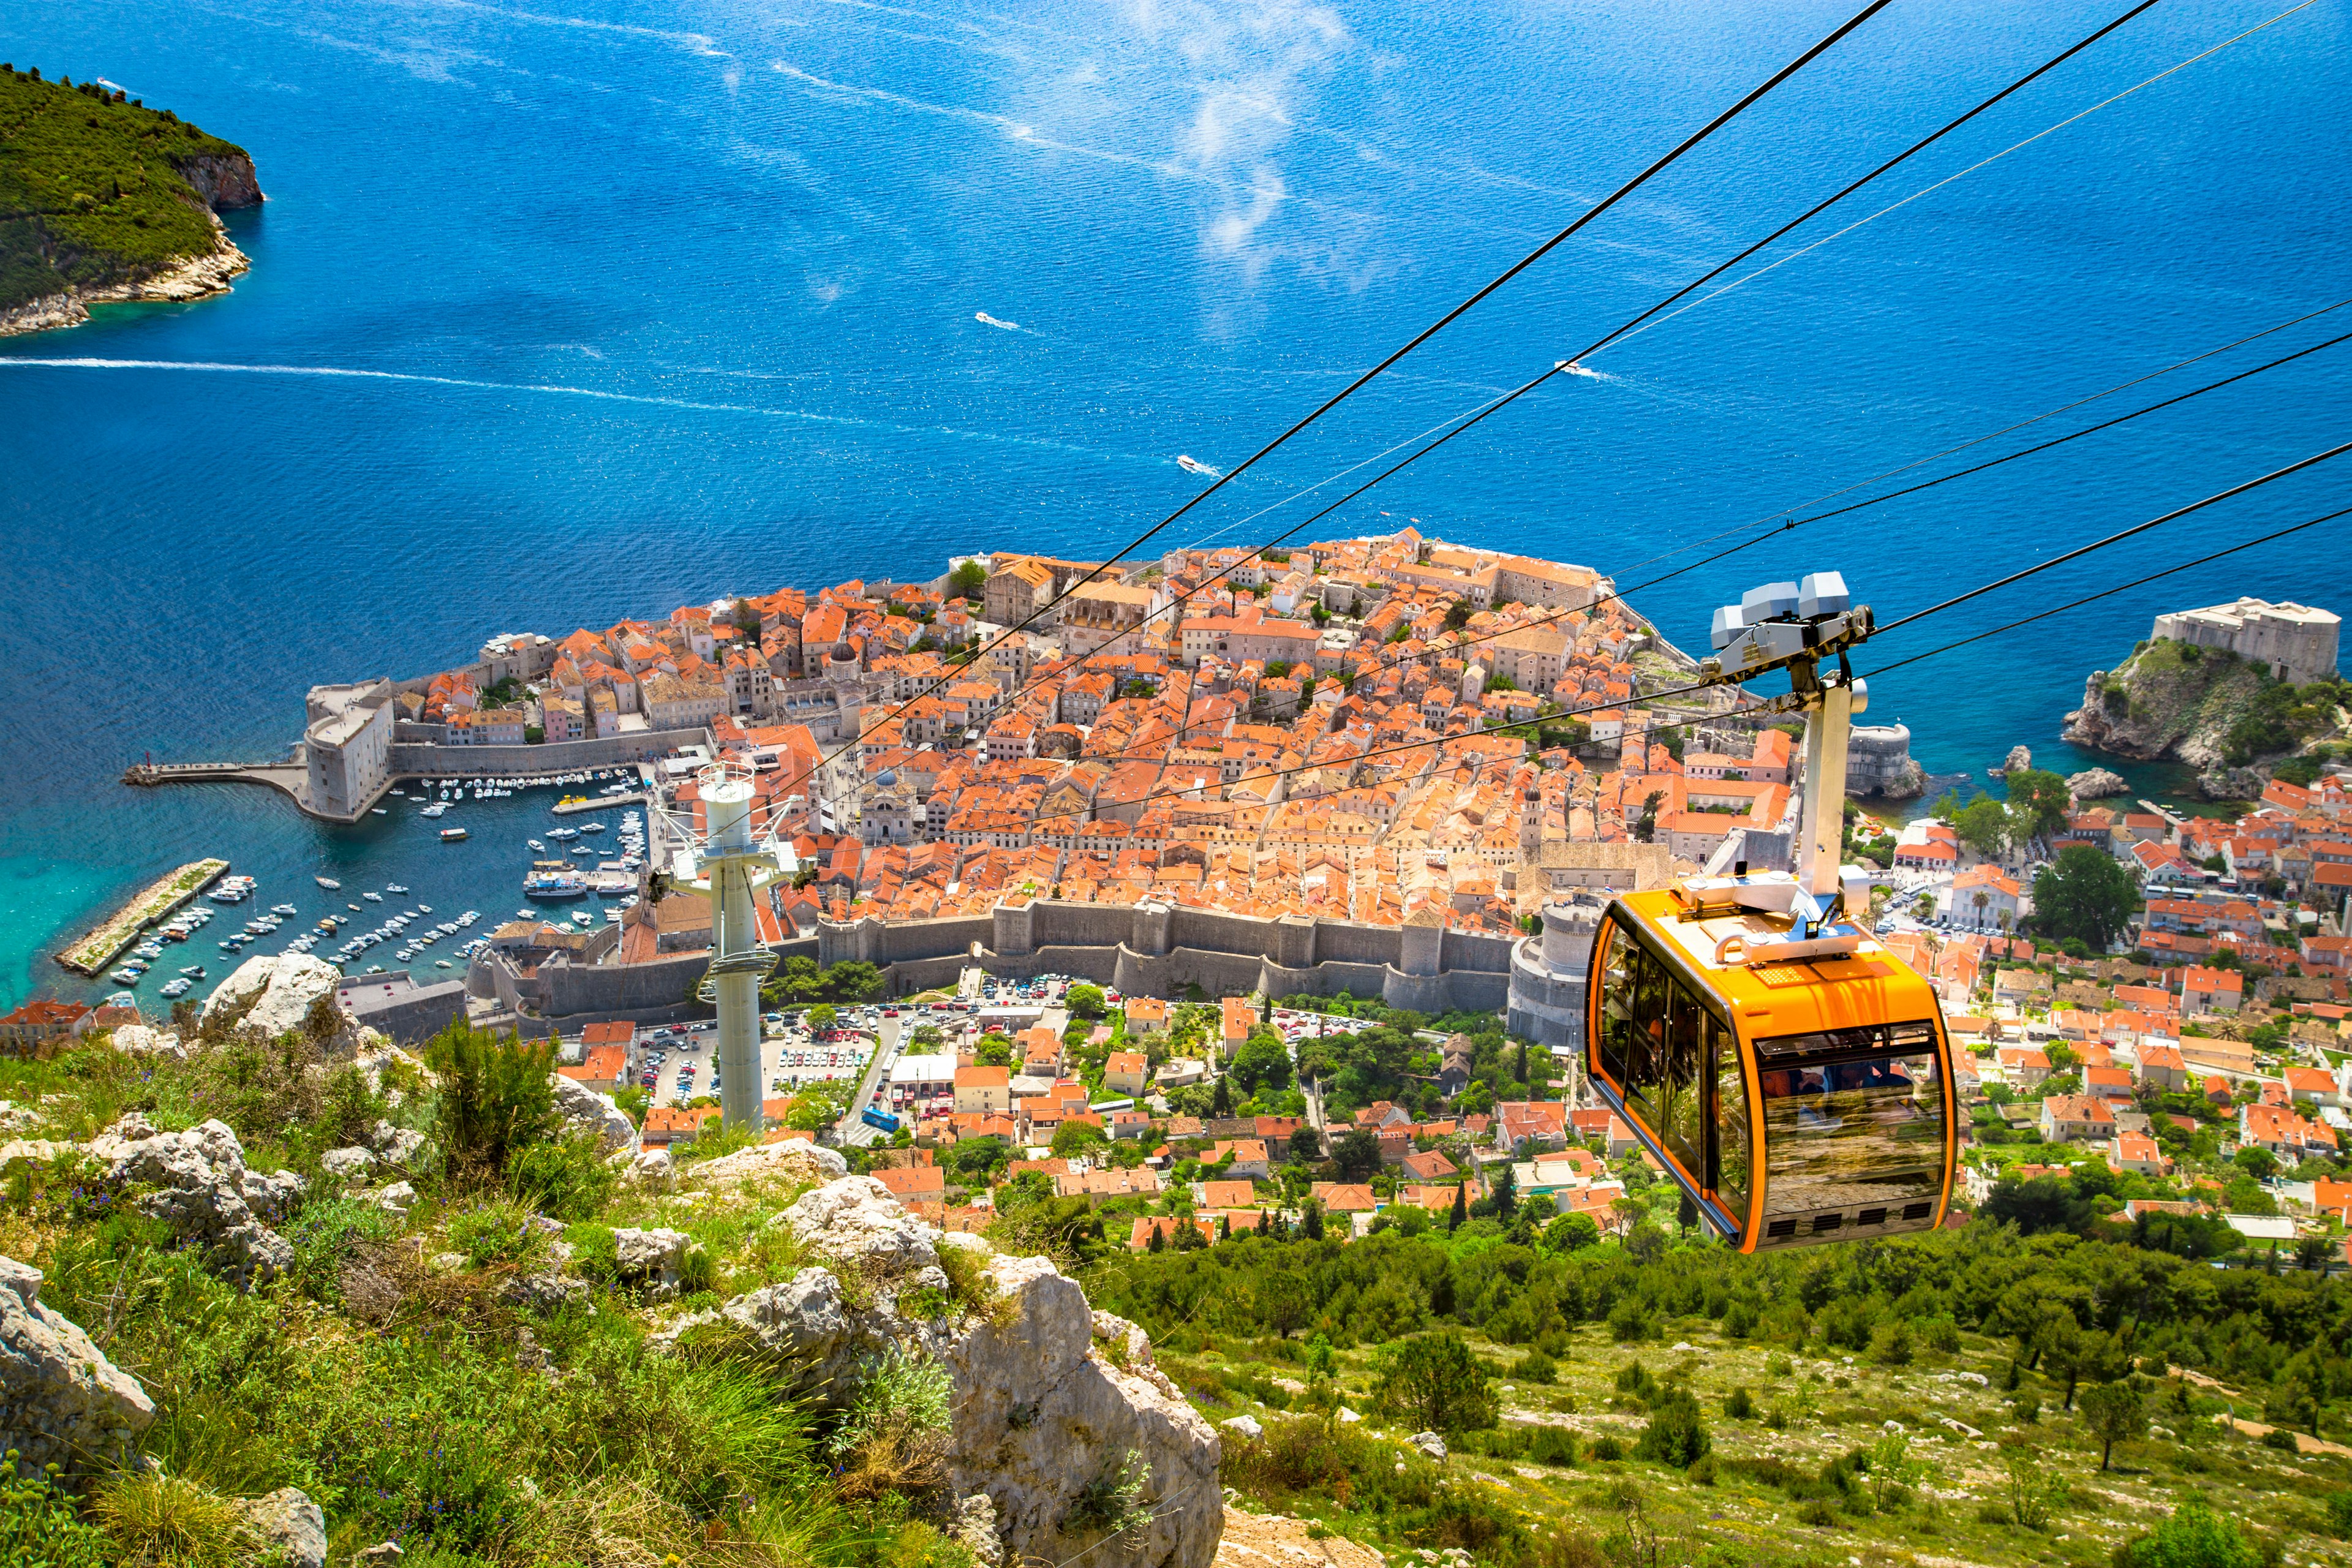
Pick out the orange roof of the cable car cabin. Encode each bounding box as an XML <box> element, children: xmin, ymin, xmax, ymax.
<box><xmin>1616</xmin><ymin>889</ymin><xmax>1938</xmax><ymax>1046</ymax></box>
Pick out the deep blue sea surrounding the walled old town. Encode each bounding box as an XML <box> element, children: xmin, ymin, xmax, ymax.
<box><xmin>0</xmin><ymin>0</ymin><xmax>2352</xmax><ymax>1004</ymax></box>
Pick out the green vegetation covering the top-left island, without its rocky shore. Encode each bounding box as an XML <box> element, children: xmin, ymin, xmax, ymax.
<box><xmin>0</xmin><ymin>68</ymin><xmax>244</xmax><ymax>311</ymax></box>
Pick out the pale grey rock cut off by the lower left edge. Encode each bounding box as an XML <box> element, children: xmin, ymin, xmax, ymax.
<box><xmin>0</xmin><ymin>1257</ymin><xmax>155</xmax><ymax>1469</ymax></box>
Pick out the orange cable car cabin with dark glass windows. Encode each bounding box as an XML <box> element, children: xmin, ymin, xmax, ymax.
<box><xmin>1585</xmin><ymin>886</ymin><xmax>1959</xmax><ymax>1253</ymax></box>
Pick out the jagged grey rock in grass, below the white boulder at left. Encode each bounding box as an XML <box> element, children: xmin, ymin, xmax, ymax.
<box><xmin>89</xmin><ymin>1112</ymin><xmax>303</xmax><ymax>1288</ymax></box>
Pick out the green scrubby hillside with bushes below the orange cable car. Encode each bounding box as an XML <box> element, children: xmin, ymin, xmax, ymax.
<box><xmin>1089</xmin><ymin>1220</ymin><xmax>2352</xmax><ymax>1568</ymax></box>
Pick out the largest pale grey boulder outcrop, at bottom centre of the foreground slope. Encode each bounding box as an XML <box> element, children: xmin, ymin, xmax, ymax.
<box><xmin>673</xmin><ymin>1175</ymin><xmax>1223</xmax><ymax>1568</ymax></box>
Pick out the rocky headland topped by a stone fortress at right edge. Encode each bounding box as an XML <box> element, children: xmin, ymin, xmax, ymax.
<box><xmin>2063</xmin><ymin>600</ymin><xmax>2352</xmax><ymax>799</ymax></box>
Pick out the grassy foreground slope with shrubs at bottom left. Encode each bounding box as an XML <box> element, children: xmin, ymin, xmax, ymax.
<box><xmin>0</xmin><ymin>1032</ymin><xmax>974</xmax><ymax>1568</ymax></box>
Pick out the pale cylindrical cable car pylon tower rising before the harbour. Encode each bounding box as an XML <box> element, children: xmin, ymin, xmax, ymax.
<box><xmin>670</xmin><ymin>762</ymin><xmax>797</xmax><ymax>1133</ymax></box>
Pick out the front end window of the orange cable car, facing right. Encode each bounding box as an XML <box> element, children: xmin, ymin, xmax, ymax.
<box><xmin>1757</xmin><ymin>1023</ymin><xmax>1943</xmax><ymax>1215</ymax></box>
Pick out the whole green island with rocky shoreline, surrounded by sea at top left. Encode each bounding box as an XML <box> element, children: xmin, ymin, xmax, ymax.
<box><xmin>0</xmin><ymin>64</ymin><xmax>261</xmax><ymax>336</ymax></box>
